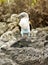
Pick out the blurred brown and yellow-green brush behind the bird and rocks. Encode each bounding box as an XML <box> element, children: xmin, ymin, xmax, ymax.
<box><xmin>0</xmin><ymin>0</ymin><xmax>48</xmax><ymax>28</ymax></box>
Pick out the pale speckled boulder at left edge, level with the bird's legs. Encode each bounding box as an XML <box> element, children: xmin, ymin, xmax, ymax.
<box><xmin>0</xmin><ymin>31</ymin><xmax>15</xmax><ymax>41</ymax></box>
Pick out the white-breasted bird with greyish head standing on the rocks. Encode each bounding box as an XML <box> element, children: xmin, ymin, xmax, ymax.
<box><xmin>18</xmin><ymin>12</ymin><xmax>30</xmax><ymax>36</ymax></box>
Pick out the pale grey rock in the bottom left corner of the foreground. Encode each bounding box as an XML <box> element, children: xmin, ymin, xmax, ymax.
<box><xmin>0</xmin><ymin>54</ymin><xmax>18</xmax><ymax>65</ymax></box>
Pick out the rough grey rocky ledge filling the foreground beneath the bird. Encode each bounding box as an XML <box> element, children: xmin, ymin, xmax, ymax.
<box><xmin>0</xmin><ymin>27</ymin><xmax>48</xmax><ymax>65</ymax></box>
